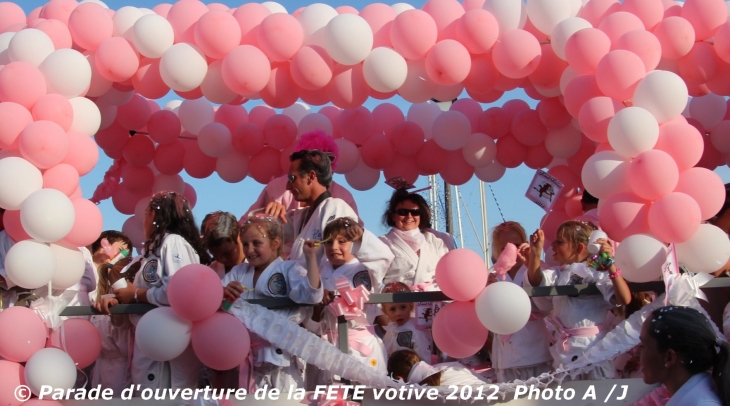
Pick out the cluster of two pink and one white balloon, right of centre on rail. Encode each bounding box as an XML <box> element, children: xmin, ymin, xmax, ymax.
<box><xmin>431</xmin><ymin>248</ymin><xmax>532</xmax><ymax>358</ymax></box>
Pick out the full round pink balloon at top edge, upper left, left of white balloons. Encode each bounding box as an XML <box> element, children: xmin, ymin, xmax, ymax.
<box><xmin>68</xmin><ymin>3</ymin><xmax>114</xmax><ymax>51</ymax></box>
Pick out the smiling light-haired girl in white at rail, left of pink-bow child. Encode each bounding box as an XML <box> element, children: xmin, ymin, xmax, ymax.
<box><xmin>222</xmin><ymin>217</ymin><xmax>323</xmax><ymax>390</ymax></box>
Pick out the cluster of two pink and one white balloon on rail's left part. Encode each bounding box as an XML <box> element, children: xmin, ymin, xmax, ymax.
<box><xmin>135</xmin><ymin>264</ymin><xmax>251</xmax><ymax>371</ymax></box>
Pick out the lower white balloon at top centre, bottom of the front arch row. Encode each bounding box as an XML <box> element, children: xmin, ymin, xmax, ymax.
<box><xmin>363</xmin><ymin>47</ymin><xmax>408</xmax><ymax>93</ymax></box>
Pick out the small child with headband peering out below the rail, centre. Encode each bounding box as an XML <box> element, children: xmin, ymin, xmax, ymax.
<box><xmin>382</xmin><ymin>282</ymin><xmax>432</xmax><ymax>362</ymax></box>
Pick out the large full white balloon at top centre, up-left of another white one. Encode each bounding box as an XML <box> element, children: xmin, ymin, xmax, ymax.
<box><xmin>325</xmin><ymin>13</ymin><xmax>373</xmax><ymax>65</ymax></box>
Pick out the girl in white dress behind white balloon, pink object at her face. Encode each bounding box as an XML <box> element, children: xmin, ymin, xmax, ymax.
<box><xmin>490</xmin><ymin>221</ymin><xmax>552</xmax><ymax>382</ymax></box>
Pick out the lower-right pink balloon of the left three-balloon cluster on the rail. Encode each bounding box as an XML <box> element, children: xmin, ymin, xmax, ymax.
<box><xmin>191</xmin><ymin>314</ymin><xmax>251</xmax><ymax>371</ymax></box>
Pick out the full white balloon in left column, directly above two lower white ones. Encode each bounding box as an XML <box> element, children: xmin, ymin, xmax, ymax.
<box><xmin>20</xmin><ymin>189</ymin><xmax>76</xmax><ymax>242</ymax></box>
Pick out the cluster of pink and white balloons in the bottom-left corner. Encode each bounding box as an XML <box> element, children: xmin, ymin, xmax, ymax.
<box><xmin>0</xmin><ymin>308</ymin><xmax>102</xmax><ymax>406</ymax></box>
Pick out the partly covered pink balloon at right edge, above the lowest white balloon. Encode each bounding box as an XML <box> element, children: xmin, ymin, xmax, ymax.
<box><xmin>674</xmin><ymin>168</ymin><xmax>725</xmax><ymax>220</ymax></box>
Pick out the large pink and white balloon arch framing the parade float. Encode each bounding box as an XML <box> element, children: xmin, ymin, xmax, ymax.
<box><xmin>0</xmin><ymin>0</ymin><xmax>730</xmax><ymax>288</ymax></box>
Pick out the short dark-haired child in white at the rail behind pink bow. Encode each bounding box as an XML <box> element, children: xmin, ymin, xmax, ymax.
<box><xmin>309</xmin><ymin>217</ymin><xmax>393</xmax><ymax>380</ymax></box>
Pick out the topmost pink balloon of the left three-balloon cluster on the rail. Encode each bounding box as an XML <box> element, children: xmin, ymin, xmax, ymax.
<box><xmin>167</xmin><ymin>264</ymin><xmax>223</xmax><ymax>321</ymax></box>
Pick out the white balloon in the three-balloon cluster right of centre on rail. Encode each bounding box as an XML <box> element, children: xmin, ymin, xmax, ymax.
<box><xmin>474</xmin><ymin>281</ymin><xmax>532</xmax><ymax>334</ymax></box>
